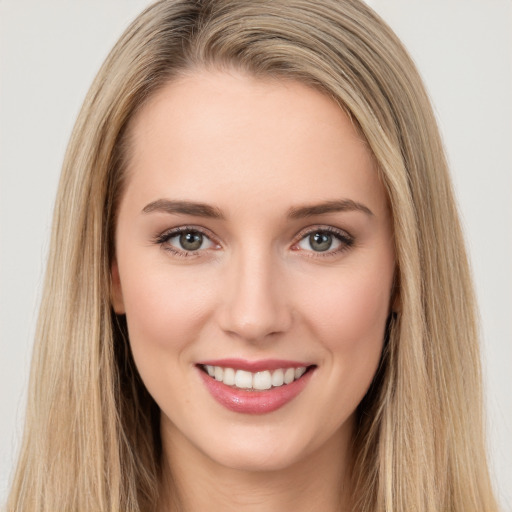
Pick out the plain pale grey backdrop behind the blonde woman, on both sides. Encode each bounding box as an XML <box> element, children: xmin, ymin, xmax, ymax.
<box><xmin>0</xmin><ymin>0</ymin><xmax>512</xmax><ymax>511</ymax></box>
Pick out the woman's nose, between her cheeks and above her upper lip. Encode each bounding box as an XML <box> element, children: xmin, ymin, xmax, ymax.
<box><xmin>219</xmin><ymin>248</ymin><xmax>293</xmax><ymax>342</ymax></box>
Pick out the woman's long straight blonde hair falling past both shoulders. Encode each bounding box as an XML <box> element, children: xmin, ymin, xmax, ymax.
<box><xmin>8</xmin><ymin>0</ymin><xmax>497</xmax><ymax>512</ymax></box>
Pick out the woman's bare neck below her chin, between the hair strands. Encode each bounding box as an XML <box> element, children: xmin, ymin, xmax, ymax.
<box><xmin>159</xmin><ymin>420</ymin><xmax>350</xmax><ymax>512</ymax></box>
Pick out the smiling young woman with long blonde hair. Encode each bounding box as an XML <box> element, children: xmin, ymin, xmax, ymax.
<box><xmin>8</xmin><ymin>1</ymin><xmax>496</xmax><ymax>511</ymax></box>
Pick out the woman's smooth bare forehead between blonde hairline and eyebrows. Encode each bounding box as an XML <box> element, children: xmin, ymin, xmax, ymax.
<box><xmin>123</xmin><ymin>67</ymin><xmax>386</xmax><ymax>214</ymax></box>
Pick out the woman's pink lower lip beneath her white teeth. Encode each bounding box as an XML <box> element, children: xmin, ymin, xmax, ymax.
<box><xmin>198</xmin><ymin>369</ymin><xmax>313</xmax><ymax>414</ymax></box>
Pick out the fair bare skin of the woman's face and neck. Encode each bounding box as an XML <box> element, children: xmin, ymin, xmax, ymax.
<box><xmin>112</xmin><ymin>70</ymin><xmax>395</xmax><ymax>512</ymax></box>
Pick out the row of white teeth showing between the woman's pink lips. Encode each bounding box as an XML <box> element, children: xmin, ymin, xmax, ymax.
<box><xmin>198</xmin><ymin>364</ymin><xmax>316</xmax><ymax>392</ymax></box>
